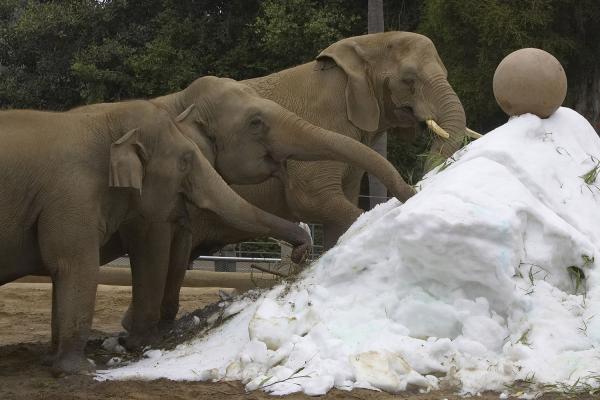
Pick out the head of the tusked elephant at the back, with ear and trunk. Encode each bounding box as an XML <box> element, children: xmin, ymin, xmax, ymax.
<box><xmin>317</xmin><ymin>32</ymin><xmax>466</xmax><ymax>169</ymax></box>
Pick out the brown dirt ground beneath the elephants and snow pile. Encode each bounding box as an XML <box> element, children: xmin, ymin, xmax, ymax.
<box><xmin>0</xmin><ymin>283</ymin><xmax>599</xmax><ymax>400</ymax></box>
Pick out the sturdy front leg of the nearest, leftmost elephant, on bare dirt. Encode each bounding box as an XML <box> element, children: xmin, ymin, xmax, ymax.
<box><xmin>39</xmin><ymin>221</ymin><xmax>99</xmax><ymax>375</ymax></box>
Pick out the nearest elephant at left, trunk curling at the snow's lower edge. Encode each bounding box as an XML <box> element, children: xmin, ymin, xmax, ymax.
<box><xmin>0</xmin><ymin>100</ymin><xmax>310</xmax><ymax>375</ymax></box>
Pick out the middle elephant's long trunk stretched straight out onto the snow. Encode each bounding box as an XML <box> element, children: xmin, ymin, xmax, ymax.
<box><xmin>270</xmin><ymin>112</ymin><xmax>415</xmax><ymax>202</ymax></box>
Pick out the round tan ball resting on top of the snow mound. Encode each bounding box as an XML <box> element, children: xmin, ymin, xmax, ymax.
<box><xmin>493</xmin><ymin>48</ymin><xmax>567</xmax><ymax>118</ymax></box>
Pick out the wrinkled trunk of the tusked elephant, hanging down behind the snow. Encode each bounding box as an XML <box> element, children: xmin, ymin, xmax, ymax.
<box><xmin>423</xmin><ymin>76</ymin><xmax>466</xmax><ymax>172</ymax></box>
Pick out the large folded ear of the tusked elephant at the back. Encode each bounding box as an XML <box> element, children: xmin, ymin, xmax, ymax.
<box><xmin>317</xmin><ymin>39</ymin><xmax>380</xmax><ymax>132</ymax></box>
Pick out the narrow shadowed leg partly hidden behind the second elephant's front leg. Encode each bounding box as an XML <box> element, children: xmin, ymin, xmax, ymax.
<box><xmin>160</xmin><ymin>227</ymin><xmax>192</xmax><ymax>327</ymax></box>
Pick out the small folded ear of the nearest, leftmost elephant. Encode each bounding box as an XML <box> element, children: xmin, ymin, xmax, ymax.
<box><xmin>108</xmin><ymin>129</ymin><xmax>146</xmax><ymax>194</ymax></box>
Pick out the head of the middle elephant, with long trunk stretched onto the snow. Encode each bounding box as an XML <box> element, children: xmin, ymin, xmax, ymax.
<box><xmin>155</xmin><ymin>76</ymin><xmax>414</xmax><ymax>201</ymax></box>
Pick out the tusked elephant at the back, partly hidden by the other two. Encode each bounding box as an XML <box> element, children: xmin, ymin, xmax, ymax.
<box><xmin>148</xmin><ymin>32</ymin><xmax>466</xmax><ymax>332</ymax></box>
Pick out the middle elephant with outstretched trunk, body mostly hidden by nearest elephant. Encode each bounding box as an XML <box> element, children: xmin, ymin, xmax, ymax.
<box><xmin>86</xmin><ymin>77</ymin><xmax>414</xmax><ymax>348</ymax></box>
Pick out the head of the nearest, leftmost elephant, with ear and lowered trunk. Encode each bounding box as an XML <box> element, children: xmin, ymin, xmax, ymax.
<box><xmin>109</xmin><ymin>106</ymin><xmax>310</xmax><ymax>262</ymax></box>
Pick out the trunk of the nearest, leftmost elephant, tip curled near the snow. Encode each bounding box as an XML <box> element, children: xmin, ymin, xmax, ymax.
<box><xmin>184</xmin><ymin>150</ymin><xmax>311</xmax><ymax>262</ymax></box>
